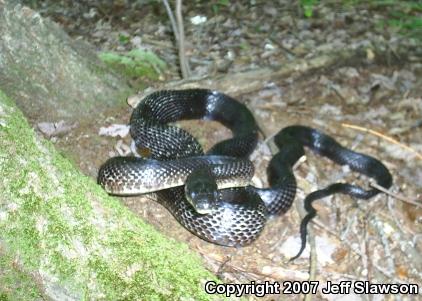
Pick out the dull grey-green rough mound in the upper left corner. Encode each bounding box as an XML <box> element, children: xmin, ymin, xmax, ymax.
<box><xmin>0</xmin><ymin>0</ymin><xmax>130</xmax><ymax>123</ymax></box>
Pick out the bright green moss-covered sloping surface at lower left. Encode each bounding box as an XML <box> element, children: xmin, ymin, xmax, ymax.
<box><xmin>0</xmin><ymin>91</ymin><xmax>215</xmax><ymax>300</ymax></box>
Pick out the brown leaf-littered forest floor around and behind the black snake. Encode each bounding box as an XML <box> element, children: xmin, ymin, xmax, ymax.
<box><xmin>23</xmin><ymin>0</ymin><xmax>422</xmax><ymax>300</ymax></box>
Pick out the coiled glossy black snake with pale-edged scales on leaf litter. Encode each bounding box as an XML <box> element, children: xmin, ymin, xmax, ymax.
<box><xmin>98</xmin><ymin>89</ymin><xmax>392</xmax><ymax>258</ymax></box>
